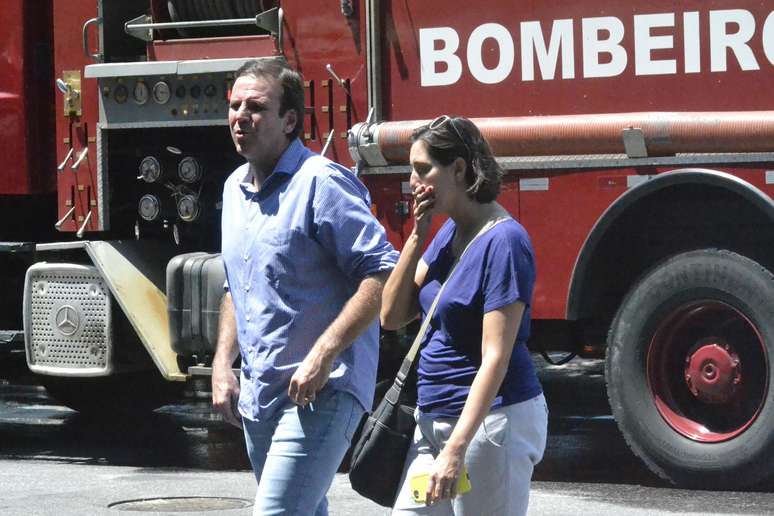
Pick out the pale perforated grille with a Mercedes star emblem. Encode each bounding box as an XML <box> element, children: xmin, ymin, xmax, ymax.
<box><xmin>24</xmin><ymin>263</ymin><xmax>112</xmax><ymax>376</ymax></box>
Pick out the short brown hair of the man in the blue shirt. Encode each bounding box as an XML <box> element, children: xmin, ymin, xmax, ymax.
<box><xmin>234</xmin><ymin>58</ymin><xmax>305</xmax><ymax>140</ymax></box>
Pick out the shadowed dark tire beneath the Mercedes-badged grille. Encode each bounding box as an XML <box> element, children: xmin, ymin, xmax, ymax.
<box><xmin>39</xmin><ymin>371</ymin><xmax>184</xmax><ymax>416</ymax></box>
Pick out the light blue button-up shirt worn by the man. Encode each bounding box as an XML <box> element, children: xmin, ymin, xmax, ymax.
<box><xmin>222</xmin><ymin>139</ymin><xmax>398</xmax><ymax>420</ymax></box>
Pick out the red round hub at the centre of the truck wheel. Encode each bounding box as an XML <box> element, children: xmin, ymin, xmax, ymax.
<box><xmin>685</xmin><ymin>342</ymin><xmax>742</xmax><ymax>404</ymax></box>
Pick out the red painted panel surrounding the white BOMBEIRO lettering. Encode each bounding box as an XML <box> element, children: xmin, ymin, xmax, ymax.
<box><xmin>384</xmin><ymin>0</ymin><xmax>774</xmax><ymax>120</ymax></box>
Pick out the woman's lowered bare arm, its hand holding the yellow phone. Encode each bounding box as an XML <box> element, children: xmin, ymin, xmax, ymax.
<box><xmin>426</xmin><ymin>301</ymin><xmax>524</xmax><ymax>503</ymax></box>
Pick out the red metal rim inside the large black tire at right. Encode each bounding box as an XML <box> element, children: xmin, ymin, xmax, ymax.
<box><xmin>646</xmin><ymin>300</ymin><xmax>769</xmax><ymax>443</ymax></box>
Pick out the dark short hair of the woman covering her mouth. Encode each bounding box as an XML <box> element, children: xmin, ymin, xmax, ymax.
<box><xmin>411</xmin><ymin>117</ymin><xmax>503</xmax><ymax>204</ymax></box>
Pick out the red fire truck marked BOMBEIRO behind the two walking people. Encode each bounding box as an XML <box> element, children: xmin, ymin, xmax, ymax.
<box><xmin>0</xmin><ymin>0</ymin><xmax>774</xmax><ymax>488</ymax></box>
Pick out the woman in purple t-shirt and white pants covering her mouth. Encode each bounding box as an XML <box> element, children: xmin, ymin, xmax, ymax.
<box><xmin>381</xmin><ymin>116</ymin><xmax>548</xmax><ymax>516</ymax></box>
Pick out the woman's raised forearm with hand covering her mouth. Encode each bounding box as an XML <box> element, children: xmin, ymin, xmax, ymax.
<box><xmin>380</xmin><ymin>186</ymin><xmax>435</xmax><ymax>330</ymax></box>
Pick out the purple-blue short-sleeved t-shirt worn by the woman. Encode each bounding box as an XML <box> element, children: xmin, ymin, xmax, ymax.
<box><xmin>417</xmin><ymin>219</ymin><xmax>542</xmax><ymax>417</ymax></box>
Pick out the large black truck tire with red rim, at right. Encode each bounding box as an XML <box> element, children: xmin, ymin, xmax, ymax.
<box><xmin>605</xmin><ymin>249</ymin><xmax>774</xmax><ymax>489</ymax></box>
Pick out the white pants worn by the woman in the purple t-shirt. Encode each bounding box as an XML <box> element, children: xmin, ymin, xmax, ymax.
<box><xmin>392</xmin><ymin>394</ymin><xmax>548</xmax><ymax>516</ymax></box>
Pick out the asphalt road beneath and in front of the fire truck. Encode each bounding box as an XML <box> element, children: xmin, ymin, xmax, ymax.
<box><xmin>0</xmin><ymin>358</ymin><xmax>774</xmax><ymax>516</ymax></box>
